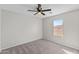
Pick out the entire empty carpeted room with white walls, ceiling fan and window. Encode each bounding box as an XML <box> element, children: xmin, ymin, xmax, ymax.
<box><xmin>0</xmin><ymin>4</ymin><xmax>79</xmax><ymax>54</ymax></box>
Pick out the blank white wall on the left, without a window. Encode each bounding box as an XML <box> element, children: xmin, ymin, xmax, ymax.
<box><xmin>1</xmin><ymin>10</ymin><xmax>42</xmax><ymax>49</ymax></box>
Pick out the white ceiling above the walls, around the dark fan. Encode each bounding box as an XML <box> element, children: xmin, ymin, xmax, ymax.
<box><xmin>0</xmin><ymin>4</ymin><xmax>79</xmax><ymax>18</ymax></box>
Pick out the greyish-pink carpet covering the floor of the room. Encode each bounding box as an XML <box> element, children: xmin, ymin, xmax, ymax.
<box><xmin>1</xmin><ymin>40</ymin><xmax>79</xmax><ymax>54</ymax></box>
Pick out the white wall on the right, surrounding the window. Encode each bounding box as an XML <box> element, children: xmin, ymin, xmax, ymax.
<box><xmin>43</xmin><ymin>10</ymin><xmax>79</xmax><ymax>50</ymax></box>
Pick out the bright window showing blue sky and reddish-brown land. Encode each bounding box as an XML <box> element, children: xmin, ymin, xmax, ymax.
<box><xmin>53</xmin><ymin>19</ymin><xmax>64</xmax><ymax>38</ymax></box>
